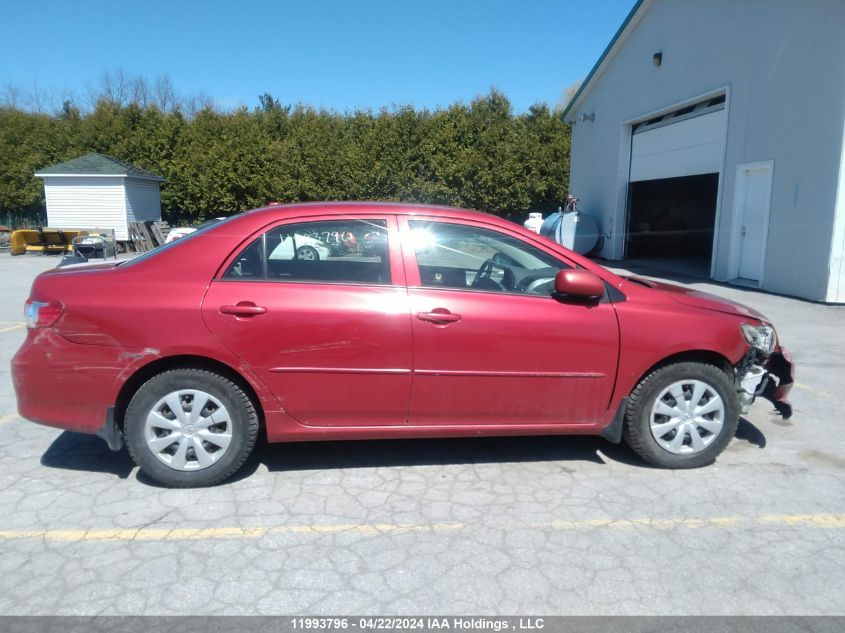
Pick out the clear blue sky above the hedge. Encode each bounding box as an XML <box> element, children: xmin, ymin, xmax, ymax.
<box><xmin>0</xmin><ymin>0</ymin><xmax>634</xmax><ymax>111</ymax></box>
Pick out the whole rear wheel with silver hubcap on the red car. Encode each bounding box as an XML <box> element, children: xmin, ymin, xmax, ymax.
<box><xmin>124</xmin><ymin>369</ymin><xmax>258</xmax><ymax>488</ymax></box>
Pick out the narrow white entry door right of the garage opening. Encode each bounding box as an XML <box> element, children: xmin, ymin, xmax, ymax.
<box><xmin>734</xmin><ymin>162</ymin><xmax>772</xmax><ymax>283</ymax></box>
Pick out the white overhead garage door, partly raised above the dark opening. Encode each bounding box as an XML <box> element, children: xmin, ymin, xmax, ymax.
<box><xmin>630</xmin><ymin>106</ymin><xmax>725</xmax><ymax>182</ymax></box>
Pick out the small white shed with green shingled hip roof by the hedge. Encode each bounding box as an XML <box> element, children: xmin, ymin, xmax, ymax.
<box><xmin>35</xmin><ymin>152</ymin><xmax>164</xmax><ymax>240</ymax></box>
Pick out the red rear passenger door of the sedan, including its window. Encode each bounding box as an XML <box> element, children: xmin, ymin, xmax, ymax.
<box><xmin>202</xmin><ymin>215</ymin><xmax>411</xmax><ymax>426</ymax></box>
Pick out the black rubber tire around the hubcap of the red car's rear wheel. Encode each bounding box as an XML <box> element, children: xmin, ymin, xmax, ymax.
<box><xmin>123</xmin><ymin>369</ymin><xmax>259</xmax><ymax>488</ymax></box>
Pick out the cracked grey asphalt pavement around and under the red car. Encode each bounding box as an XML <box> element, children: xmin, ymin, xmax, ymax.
<box><xmin>0</xmin><ymin>253</ymin><xmax>845</xmax><ymax>615</ymax></box>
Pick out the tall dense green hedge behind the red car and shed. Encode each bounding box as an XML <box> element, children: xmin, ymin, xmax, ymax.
<box><xmin>0</xmin><ymin>90</ymin><xmax>570</xmax><ymax>223</ymax></box>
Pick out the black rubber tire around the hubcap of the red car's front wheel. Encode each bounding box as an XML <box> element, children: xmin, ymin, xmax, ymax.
<box><xmin>623</xmin><ymin>362</ymin><xmax>739</xmax><ymax>469</ymax></box>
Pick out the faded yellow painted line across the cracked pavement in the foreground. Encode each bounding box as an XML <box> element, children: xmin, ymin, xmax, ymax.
<box><xmin>0</xmin><ymin>514</ymin><xmax>845</xmax><ymax>543</ymax></box>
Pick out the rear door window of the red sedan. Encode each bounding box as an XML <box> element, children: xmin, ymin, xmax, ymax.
<box><xmin>223</xmin><ymin>220</ymin><xmax>391</xmax><ymax>284</ymax></box>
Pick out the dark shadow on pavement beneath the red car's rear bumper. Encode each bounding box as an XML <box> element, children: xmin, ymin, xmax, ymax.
<box><xmin>41</xmin><ymin>431</ymin><xmax>135</xmax><ymax>479</ymax></box>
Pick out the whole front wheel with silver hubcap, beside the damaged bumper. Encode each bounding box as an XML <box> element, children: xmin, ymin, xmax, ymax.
<box><xmin>623</xmin><ymin>362</ymin><xmax>739</xmax><ymax>468</ymax></box>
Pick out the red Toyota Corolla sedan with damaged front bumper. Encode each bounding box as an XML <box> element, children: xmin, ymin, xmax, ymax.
<box><xmin>12</xmin><ymin>203</ymin><xmax>792</xmax><ymax>486</ymax></box>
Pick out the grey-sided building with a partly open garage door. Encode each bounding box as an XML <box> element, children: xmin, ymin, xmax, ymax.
<box><xmin>564</xmin><ymin>0</ymin><xmax>845</xmax><ymax>302</ymax></box>
